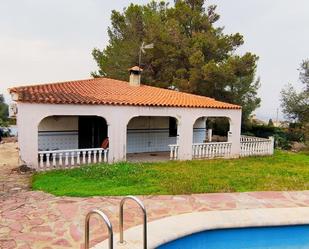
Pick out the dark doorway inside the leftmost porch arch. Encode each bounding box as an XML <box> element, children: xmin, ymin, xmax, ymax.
<box><xmin>78</xmin><ymin>116</ymin><xmax>107</xmax><ymax>149</ymax></box>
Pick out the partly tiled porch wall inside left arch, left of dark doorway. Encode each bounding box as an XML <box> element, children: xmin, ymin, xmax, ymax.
<box><xmin>38</xmin><ymin>116</ymin><xmax>78</xmax><ymax>151</ymax></box>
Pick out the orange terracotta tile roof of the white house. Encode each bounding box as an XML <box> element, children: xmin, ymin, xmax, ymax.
<box><xmin>9</xmin><ymin>78</ymin><xmax>241</xmax><ymax>109</ymax></box>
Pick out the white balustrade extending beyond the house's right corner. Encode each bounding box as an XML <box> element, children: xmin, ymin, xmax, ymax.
<box><xmin>240</xmin><ymin>136</ymin><xmax>274</xmax><ymax>157</ymax></box>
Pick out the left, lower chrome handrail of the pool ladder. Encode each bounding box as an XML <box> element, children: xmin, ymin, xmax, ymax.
<box><xmin>85</xmin><ymin>209</ymin><xmax>114</xmax><ymax>249</ymax></box>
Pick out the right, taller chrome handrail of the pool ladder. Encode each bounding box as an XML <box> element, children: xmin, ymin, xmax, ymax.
<box><xmin>119</xmin><ymin>195</ymin><xmax>147</xmax><ymax>249</ymax></box>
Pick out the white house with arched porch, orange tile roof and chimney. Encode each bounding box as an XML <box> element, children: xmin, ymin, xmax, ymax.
<box><xmin>9</xmin><ymin>67</ymin><xmax>269</xmax><ymax>170</ymax></box>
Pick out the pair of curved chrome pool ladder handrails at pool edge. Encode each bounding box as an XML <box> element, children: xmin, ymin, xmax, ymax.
<box><xmin>85</xmin><ymin>195</ymin><xmax>147</xmax><ymax>249</ymax></box>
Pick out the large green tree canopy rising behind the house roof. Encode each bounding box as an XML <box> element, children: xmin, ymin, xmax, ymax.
<box><xmin>92</xmin><ymin>0</ymin><xmax>260</xmax><ymax>119</ymax></box>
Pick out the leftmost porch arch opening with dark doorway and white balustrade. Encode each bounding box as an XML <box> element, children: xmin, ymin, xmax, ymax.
<box><xmin>38</xmin><ymin>115</ymin><xmax>108</xmax><ymax>170</ymax></box>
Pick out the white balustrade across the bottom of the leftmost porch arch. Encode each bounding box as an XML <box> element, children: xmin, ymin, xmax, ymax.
<box><xmin>38</xmin><ymin>148</ymin><xmax>108</xmax><ymax>171</ymax></box>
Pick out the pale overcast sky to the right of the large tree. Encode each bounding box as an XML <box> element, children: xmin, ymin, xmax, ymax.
<box><xmin>210</xmin><ymin>0</ymin><xmax>309</xmax><ymax>120</ymax></box>
